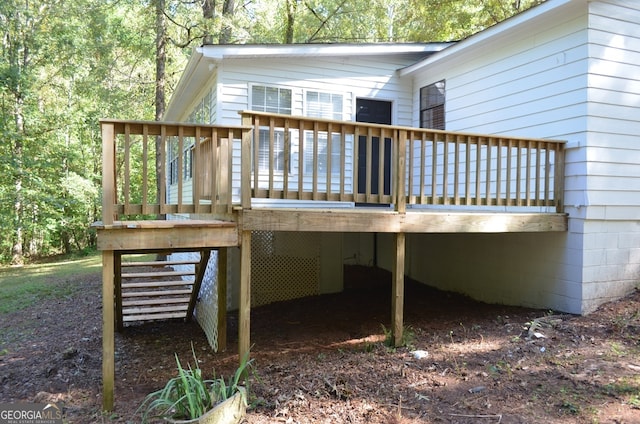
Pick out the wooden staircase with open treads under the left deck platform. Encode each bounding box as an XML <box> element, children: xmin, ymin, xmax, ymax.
<box><xmin>114</xmin><ymin>249</ymin><xmax>211</xmax><ymax>331</ymax></box>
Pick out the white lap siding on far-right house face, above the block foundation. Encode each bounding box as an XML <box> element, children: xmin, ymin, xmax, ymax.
<box><xmin>587</xmin><ymin>2</ymin><xmax>640</xmax><ymax>214</ymax></box>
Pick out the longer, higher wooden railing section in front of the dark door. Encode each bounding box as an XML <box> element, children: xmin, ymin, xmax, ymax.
<box><xmin>242</xmin><ymin>112</ymin><xmax>564</xmax><ymax>212</ymax></box>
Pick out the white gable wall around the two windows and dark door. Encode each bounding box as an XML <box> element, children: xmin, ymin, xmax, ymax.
<box><xmin>216</xmin><ymin>57</ymin><xmax>415</xmax><ymax>200</ymax></box>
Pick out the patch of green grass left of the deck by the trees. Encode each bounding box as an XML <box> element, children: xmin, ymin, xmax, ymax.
<box><xmin>0</xmin><ymin>252</ymin><xmax>102</xmax><ymax>315</ymax></box>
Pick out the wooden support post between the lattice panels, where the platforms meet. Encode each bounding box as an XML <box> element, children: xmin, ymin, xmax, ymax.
<box><xmin>238</xmin><ymin>231</ymin><xmax>251</xmax><ymax>362</ymax></box>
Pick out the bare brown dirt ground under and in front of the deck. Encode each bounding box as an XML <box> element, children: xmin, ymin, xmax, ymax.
<box><xmin>0</xmin><ymin>267</ymin><xmax>640</xmax><ymax>424</ymax></box>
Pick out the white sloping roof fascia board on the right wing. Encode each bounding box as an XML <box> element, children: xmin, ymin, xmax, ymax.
<box><xmin>399</xmin><ymin>0</ymin><xmax>587</xmax><ymax>76</ymax></box>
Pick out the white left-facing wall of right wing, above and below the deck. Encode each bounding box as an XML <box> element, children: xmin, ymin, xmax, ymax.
<box><xmin>408</xmin><ymin>3</ymin><xmax>588</xmax><ymax>313</ymax></box>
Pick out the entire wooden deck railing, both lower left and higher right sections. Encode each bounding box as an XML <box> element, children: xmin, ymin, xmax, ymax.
<box><xmin>101</xmin><ymin>112</ymin><xmax>564</xmax><ymax>225</ymax></box>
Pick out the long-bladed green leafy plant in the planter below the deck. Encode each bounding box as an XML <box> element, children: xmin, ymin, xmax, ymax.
<box><xmin>138</xmin><ymin>346</ymin><xmax>253</xmax><ymax>423</ymax></box>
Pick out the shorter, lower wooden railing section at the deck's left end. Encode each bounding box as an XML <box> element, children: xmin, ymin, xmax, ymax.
<box><xmin>101</xmin><ymin>120</ymin><xmax>249</xmax><ymax>225</ymax></box>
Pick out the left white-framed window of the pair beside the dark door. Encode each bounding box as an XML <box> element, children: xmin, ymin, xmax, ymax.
<box><xmin>251</xmin><ymin>85</ymin><xmax>291</xmax><ymax>172</ymax></box>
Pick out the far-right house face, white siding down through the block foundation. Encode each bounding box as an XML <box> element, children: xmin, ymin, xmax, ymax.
<box><xmin>583</xmin><ymin>0</ymin><xmax>640</xmax><ymax>310</ymax></box>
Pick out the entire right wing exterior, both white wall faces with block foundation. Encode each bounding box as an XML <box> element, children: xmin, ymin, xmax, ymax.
<box><xmin>400</xmin><ymin>1</ymin><xmax>640</xmax><ymax>313</ymax></box>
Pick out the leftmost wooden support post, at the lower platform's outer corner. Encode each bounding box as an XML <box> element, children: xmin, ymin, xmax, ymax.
<box><xmin>102</xmin><ymin>250</ymin><xmax>115</xmax><ymax>411</ymax></box>
